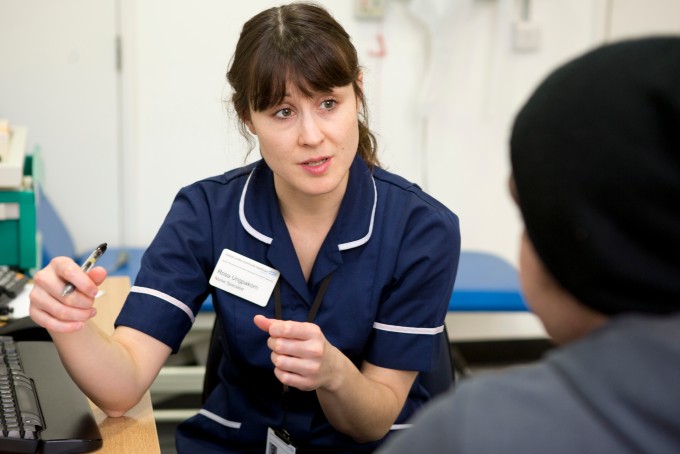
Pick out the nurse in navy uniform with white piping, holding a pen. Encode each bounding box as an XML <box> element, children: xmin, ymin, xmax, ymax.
<box><xmin>31</xmin><ymin>3</ymin><xmax>460</xmax><ymax>453</ymax></box>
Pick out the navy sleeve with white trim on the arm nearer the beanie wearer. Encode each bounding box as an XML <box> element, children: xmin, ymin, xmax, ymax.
<box><xmin>367</xmin><ymin>203</ymin><xmax>460</xmax><ymax>371</ymax></box>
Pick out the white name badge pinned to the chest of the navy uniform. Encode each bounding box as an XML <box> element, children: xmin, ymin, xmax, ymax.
<box><xmin>210</xmin><ymin>249</ymin><xmax>281</xmax><ymax>307</ymax></box>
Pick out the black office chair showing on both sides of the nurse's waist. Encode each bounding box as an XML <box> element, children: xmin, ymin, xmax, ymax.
<box><xmin>201</xmin><ymin>313</ymin><xmax>456</xmax><ymax>402</ymax></box>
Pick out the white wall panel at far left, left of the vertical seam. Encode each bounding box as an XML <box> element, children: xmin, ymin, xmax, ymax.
<box><xmin>0</xmin><ymin>0</ymin><xmax>122</xmax><ymax>252</ymax></box>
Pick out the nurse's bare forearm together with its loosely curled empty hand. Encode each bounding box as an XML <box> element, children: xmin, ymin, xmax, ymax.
<box><xmin>253</xmin><ymin>315</ymin><xmax>418</xmax><ymax>442</ymax></box>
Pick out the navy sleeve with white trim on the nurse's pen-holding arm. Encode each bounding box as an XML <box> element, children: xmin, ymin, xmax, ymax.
<box><xmin>116</xmin><ymin>185</ymin><xmax>214</xmax><ymax>352</ymax></box>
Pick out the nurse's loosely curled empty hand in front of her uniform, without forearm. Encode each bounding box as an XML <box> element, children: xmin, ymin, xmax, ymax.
<box><xmin>253</xmin><ymin>315</ymin><xmax>339</xmax><ymax>391</ymax></box>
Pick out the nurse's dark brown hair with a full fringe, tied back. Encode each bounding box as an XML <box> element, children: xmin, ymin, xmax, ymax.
<box><xmin>227</xmin><ymin>2</ymin><xmax>380</xmax><ymax>168</ymax></box>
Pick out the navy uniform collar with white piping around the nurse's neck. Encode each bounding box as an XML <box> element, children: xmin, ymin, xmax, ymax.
<box><xmin>239</xmin><ymin>155</ymin><xmax>378</xmax><ymax>251</ymax></box>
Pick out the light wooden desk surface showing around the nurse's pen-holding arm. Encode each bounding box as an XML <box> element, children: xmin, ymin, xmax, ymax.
<box><xmin>90</xmin><ymin>276</ymin><xmax>160</xmax><ymax>454</ymax></box>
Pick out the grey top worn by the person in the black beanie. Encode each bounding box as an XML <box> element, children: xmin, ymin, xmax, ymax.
<box><xmin>378</xmin><ymin>315</ymin><xmax>680</xmax><ymax>454</ymax></box>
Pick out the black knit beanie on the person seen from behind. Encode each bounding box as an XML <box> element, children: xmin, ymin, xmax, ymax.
<box><xmin>510</xmin><ymin>37</ymin><xmax>680</xmax><ymax>315</ymax></box>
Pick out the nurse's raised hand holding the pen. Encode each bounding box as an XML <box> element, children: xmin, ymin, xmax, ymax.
<box><xmin>29</xmin><ymin>257</ymin><xmax>106</xmax><ymax>333</ymax></box>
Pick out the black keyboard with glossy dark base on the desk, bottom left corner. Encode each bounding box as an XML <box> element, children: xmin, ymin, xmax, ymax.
<box><xmin>0</xmin><ymin>336</ymin><xmax>102</xmax><ymax>454</ymax></box>
